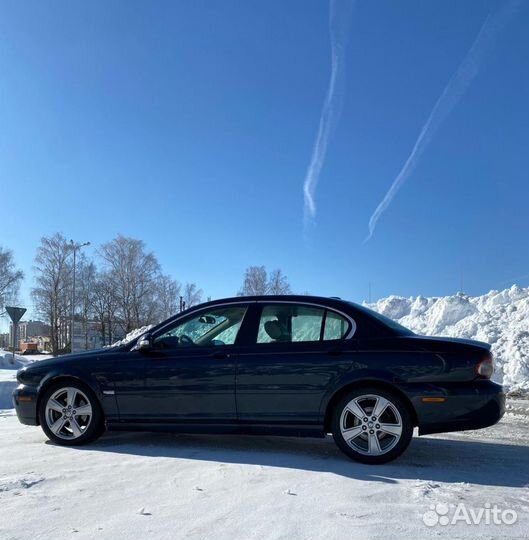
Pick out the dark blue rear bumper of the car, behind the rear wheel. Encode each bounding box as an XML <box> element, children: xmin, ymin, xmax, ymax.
<box><xmin>411</xmin><ymin>381</ymin><xmax>505</xmax><ymax>435</ymax></box>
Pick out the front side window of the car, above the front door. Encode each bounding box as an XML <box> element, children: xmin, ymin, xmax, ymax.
<box><xmin>154</xmin><ymin>306</ymin><xmax>246</xmax><ymax>349</ymax></box>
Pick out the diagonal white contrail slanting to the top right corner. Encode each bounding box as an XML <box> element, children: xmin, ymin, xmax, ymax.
<box><xmin>364</xmin><ymin>0</ymin><xmax>520</xmax><ymax>242</ymax></box>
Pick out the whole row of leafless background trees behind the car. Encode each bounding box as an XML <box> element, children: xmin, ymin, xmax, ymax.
<box><xmin>0</xmin><ymin>238</ymin><xmax>291</xmax><ymax>354</ymax></box>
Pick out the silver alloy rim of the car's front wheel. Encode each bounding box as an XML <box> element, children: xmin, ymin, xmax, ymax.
<box><xmin>46</xmin><ymin>386</ymin><xmax>92</xmax><ymax>439</ymax></box>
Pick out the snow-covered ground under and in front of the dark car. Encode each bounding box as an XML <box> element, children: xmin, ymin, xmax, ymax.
<box><xmin>0</xmin><ymin>400</ymin><xmax>529</xmax><ymax>540</ymax></box>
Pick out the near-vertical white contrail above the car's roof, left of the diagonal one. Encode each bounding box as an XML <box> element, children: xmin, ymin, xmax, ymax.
<box><xmin>303</xmin><ymin>0</ymin><xmax>354</xmax><ymax>225</ymax></box>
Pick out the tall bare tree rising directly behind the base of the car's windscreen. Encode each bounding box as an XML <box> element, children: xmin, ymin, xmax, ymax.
<box><xmin>100</xmin><ymin>235</ymin><xmax>160</xmax><ymax>332</ymax></box>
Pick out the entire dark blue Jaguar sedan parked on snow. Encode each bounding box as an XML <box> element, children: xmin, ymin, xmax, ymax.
<box><xmin>13</xmin><ymin>296</ymin><xmax>505</xmax><ymax>463</ymax></box>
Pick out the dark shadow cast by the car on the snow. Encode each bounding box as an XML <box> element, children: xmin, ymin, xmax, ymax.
<box><xmin>58</xmin><ymin>432</ymin><xmax>529</xmax><ymax>487</ymax></box>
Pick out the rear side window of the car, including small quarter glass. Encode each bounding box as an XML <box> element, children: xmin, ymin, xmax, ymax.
<box><xmin>257</xmin><ymin>304</ymin><xmax>350</xmax><ymax>343</ymax></box>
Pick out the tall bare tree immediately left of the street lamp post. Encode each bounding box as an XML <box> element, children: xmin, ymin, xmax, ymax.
<box><xmin>31</xmin><ymin>233</ymin><xmax>72</xmax><ymax>354</ymax></box>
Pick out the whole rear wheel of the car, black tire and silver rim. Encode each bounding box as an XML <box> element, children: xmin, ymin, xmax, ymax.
<box><xmin>331</xmin><ymin>387</ymin><xmax>413</xmax><ymax>465</ymax></box>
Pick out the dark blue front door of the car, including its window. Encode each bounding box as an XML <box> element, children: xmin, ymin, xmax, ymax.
<box><xmin>143</xmin><ymin>304</ymin><xmax>251</xmax><ymax>424</ymax></box>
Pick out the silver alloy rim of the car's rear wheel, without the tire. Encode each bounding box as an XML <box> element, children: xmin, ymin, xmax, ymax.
<box><xmin>340</xmin><ymin>394</ymin><xmax>402</xmax><ymax>456</ymax></box>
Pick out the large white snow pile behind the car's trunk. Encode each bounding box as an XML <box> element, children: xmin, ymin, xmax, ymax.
<box><xmin>366</xmin><ymin>285</ymin><xmax>529</xmax><ymax>390</ymax></box>
